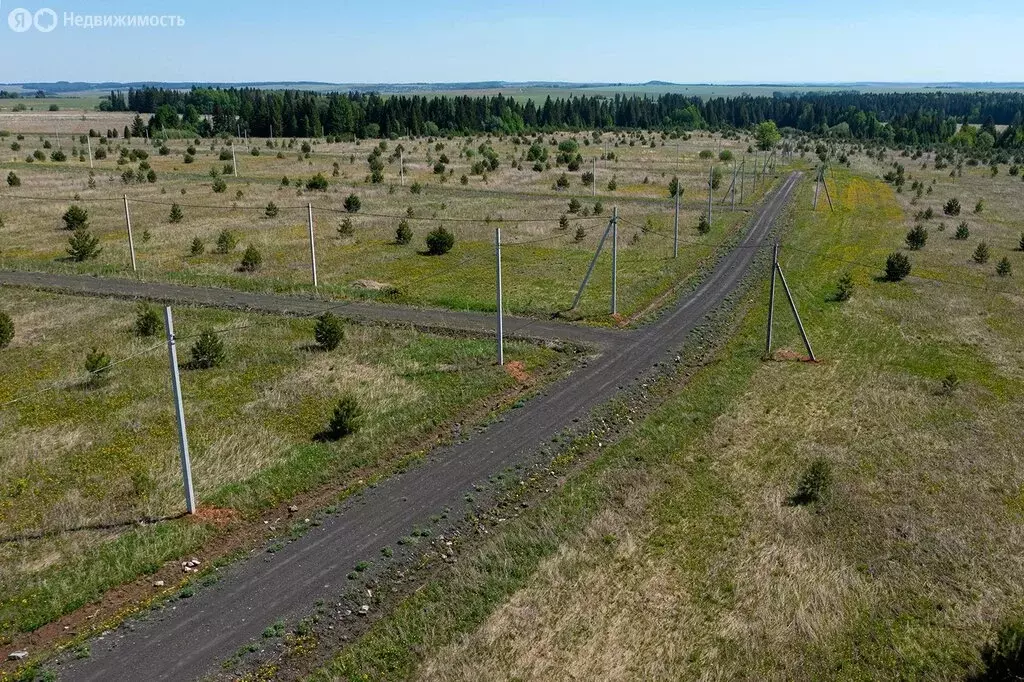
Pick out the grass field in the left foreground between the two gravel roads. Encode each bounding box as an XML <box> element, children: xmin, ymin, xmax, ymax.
<box><xmin>0</xmin><ymin>290</ymin><xmax>556</xmax><ymax>641</ymax></box>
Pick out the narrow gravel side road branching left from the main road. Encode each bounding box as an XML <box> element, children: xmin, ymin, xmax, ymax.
<box><xmin>0</xmin><ymin>270</ymin><xmax>629</xmax><ymax>345</ymax></box>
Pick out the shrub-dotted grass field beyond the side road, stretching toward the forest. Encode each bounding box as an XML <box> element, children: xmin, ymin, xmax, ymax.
<box><xmin>0</xmin><ymin>126</ymin><xmax>765</xmax><ymax>322</ymax></box>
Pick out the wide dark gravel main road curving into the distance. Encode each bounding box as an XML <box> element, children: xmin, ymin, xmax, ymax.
<box><xmin>59</xmin><ymin>173</ymin><xmax>800</xmax><ymax>682</ymax></box>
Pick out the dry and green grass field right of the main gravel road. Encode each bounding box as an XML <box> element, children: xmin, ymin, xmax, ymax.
<box><xmin>309</xmin><ymin>165</ymin><xmax>1024</xmax><ymax>680</ymax></box>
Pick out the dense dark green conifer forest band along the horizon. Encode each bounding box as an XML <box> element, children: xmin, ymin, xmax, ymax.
<box><xmin>102</xmin><ymin>87</ymin><xmax>1024</xmax><ymax>148</ymax></box>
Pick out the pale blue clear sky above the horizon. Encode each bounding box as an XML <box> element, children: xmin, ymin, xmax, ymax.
<box><xmin>0</xmin><ymin>0</ymin><xmax>1024</xmax><ymax>83</ymax></box>
